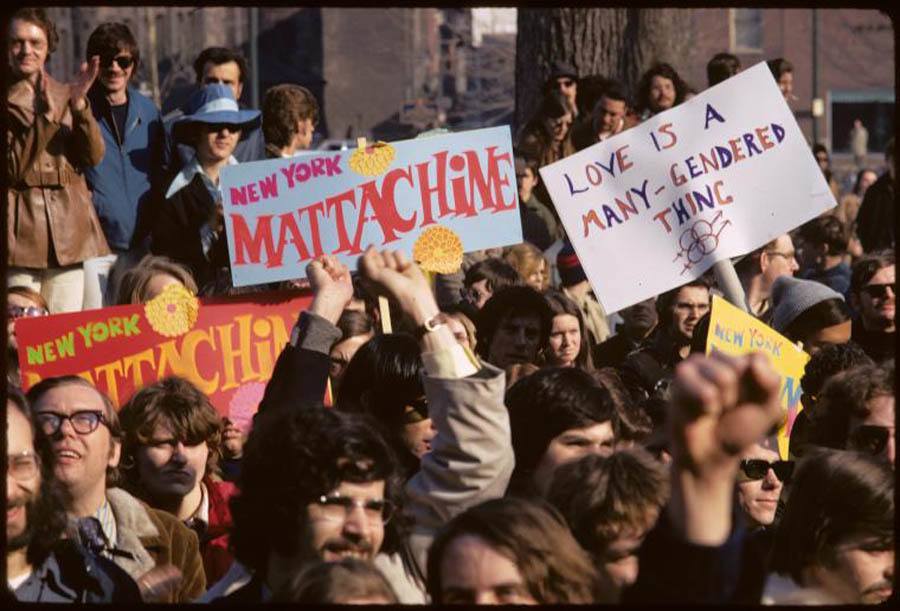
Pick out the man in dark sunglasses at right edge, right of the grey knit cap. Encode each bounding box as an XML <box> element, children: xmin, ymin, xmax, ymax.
<box><xmin>850</xmin><ymin>250</ymin><xmax>897</xmax><ymax>362</ymax></box>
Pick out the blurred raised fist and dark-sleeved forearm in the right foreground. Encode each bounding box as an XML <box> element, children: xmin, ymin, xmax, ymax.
<box><xmin>625</xmin><ymin>353</ymin><xmax>781</xmax><ymax>603</ymax></box>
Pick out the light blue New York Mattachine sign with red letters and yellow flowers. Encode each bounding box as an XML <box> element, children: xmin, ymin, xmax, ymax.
<box><xmin>221</xmin><ymin>127</ymin><xmax>522</xmax><ymax>286</ymax></box>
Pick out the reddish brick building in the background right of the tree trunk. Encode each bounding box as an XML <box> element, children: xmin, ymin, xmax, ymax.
<box><xmin>684</xmin><ymin>8</ymin><xmax>895</xmax><ymax>156</ymax></box>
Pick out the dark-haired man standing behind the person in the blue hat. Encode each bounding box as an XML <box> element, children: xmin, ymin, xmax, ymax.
<box><xmin>165</xmin><ymin>47</ymin><xmax>266</xmax><ymax>171</ymax></box>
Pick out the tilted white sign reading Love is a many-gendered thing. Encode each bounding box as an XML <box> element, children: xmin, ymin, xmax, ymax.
<box><xmin>540</xmin><ymin>63</ymin><xmax>837</xmax><ymax>312</ymax></box>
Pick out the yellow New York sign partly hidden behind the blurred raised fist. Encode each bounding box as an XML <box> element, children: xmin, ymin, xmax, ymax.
<box><xmin>706</xmin><ymin>295</ymin><xmax>809</xmax><ymax>460</ymax></box>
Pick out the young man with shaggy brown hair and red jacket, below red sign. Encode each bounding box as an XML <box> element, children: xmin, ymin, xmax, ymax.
<box><xmin>119</xmin><ymin>377</ymin><xmax>236</xmax><ymax>583</ymax></box>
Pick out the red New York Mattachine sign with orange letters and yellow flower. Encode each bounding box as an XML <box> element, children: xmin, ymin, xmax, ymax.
<box><xmin>16</xmin><ymin>287</ymin><xmax>312</xmax><ymax>423</ymax></box>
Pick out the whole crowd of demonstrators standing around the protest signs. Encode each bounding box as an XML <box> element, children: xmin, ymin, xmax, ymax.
<box><xmin>6</xmin><ymin>8</ymin><xmax>896</xmax><ymax>604</ymax></box>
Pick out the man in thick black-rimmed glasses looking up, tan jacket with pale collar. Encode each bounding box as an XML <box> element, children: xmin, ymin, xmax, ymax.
<box><xmin>28</xmin><ymin>375</ymin><xmax>206</xmax><ymax>602</ymax></box>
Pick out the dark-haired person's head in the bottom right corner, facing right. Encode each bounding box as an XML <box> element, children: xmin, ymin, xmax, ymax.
<box><xmin>762</xmin><ymin>451</ymin><xmax>895</xmax><ymax>605</ymax></box>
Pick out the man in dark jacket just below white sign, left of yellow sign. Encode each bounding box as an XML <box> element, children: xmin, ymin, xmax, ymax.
<box><xmin>622</xmin><ymin>276</ymin><xmax>710</xmax><ymax>400</ymax></box>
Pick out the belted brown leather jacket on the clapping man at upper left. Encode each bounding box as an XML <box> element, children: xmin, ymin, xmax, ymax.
<box><xmin>6</xmin><ymin>74</ymin><xmax>109</xmax><ymax>269</ymax></box>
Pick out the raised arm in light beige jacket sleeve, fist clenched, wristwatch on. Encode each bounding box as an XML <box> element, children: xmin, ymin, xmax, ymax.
<box><xmin>360</xmin><ymin>249</ymin><xmax>514</xmax><ymax>573</ymax></box>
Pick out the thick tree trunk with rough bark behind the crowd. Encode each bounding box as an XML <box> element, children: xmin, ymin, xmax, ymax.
<box><xmin>516</xmin><ymin>8</ymin><xmax>691</xmax><ymax>132</ymax></box>
